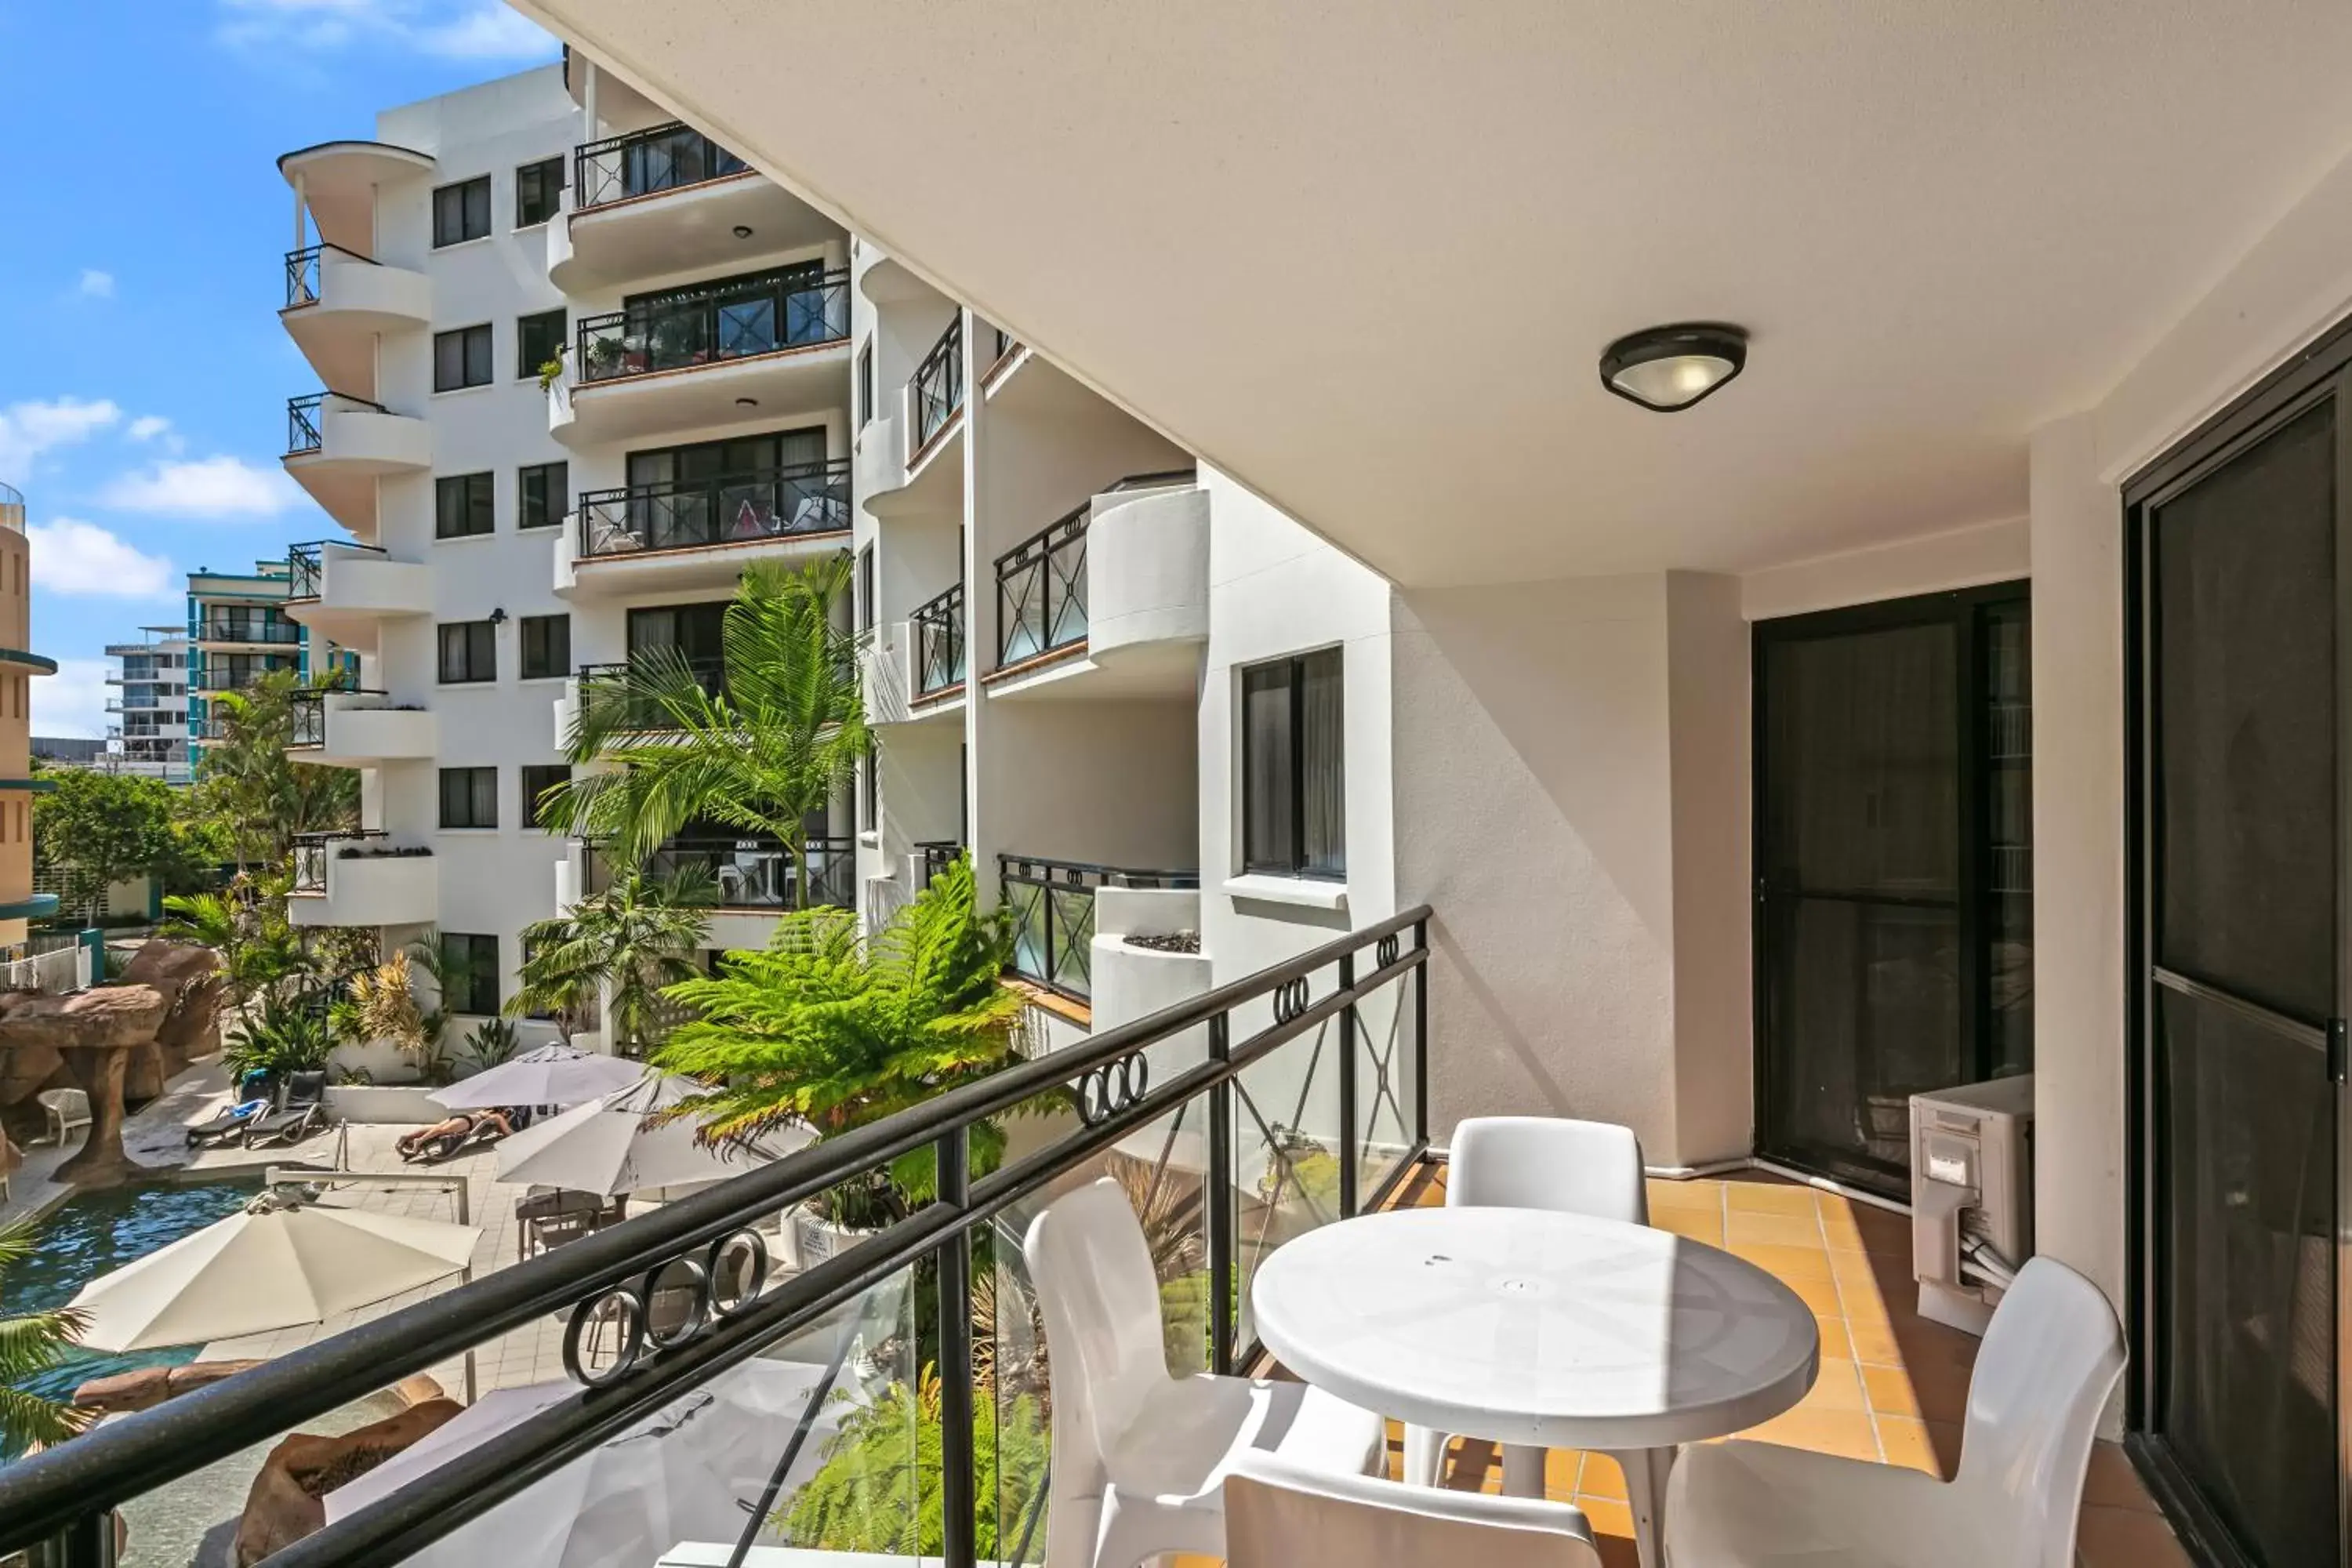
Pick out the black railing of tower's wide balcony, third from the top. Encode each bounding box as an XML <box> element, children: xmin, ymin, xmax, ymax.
<box><xmin>579</xmin><ymin>459</ymin><xmax>849</xmax><ymax>560</ymax></box>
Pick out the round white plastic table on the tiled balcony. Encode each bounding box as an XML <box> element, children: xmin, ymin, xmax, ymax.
<box><xmin>1249</xmin><ymin>1208</ymin><xmax>1820</xmax><ymax>1566</ymax></box>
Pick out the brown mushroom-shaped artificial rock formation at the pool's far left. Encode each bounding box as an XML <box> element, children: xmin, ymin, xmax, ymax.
<box><xmin>0</xmin><ymin>940</ymin><xmax>221</xmax><ymax>1187</ymax></box>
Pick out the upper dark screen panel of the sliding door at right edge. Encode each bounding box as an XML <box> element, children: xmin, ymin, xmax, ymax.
<box><xmin>2152</xmin><ymin>405</ymin><xmax>2338</xmax><ymax>1022</ymax></box>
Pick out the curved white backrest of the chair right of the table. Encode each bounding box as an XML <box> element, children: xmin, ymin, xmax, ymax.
<box><xmin>1952</xmin><ymin>1258</ymin><xmax>2124</xmax><ymax>1568</ymax></box>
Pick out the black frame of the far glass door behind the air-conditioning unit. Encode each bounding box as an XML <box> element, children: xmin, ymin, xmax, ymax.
<box><xmin>1748</xmin><ymin>579</ymin><xmax>2032</xmax><ymax>1201</ymax></box>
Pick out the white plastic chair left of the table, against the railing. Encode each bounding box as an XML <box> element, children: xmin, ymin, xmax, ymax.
<box><xmin>1023</xmin><ymin>1180</ymin><xmax>1385</xmax><ymax>1568</ymax></box>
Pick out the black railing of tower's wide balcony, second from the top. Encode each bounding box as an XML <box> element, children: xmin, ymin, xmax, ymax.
<box><xmin>572</xmin><ymin>270</ymin><xmax>849</xmax><ymax>386</ymax></box>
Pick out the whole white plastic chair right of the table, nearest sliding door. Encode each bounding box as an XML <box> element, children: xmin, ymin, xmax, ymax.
<box><xmin>1665</xmin><ymin>1258</ymin><xmax>2124</xmax><ymax>1568</ymax></box>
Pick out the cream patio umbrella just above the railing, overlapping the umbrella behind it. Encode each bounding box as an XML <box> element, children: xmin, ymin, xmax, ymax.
<box><xmin>499</xmin><ymin>1074</ymin><xmax>814</xmax><ymax>1196</ymax></box>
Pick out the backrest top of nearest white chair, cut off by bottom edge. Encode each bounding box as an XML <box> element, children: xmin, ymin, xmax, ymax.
<box><xmin>1225</xmin><ymin>1453</ymin><xmax>1602</xmax><ymax>1568</ymax></box>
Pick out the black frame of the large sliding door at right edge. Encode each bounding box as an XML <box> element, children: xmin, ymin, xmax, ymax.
<box><xmin>2119</xmin><ymin>318</ymin><xmax>2352</xmax><ymax>1568</ymax></box>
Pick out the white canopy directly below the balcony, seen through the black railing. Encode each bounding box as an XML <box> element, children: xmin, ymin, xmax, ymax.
<box><xmin>325</xmin><ymin>1359</ymin><xmax>856</xmax><ymax>1568</ymax></box>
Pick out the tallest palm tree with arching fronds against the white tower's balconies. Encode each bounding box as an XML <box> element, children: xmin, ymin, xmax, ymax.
<box><xmin>541</xmin><ymin>555</ymin><xmax>868</xmax><ymax>909</ymax></box>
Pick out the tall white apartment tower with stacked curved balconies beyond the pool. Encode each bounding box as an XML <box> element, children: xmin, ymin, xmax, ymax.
<box><xmin>280</xmin><ymin>66</ymin><xmax>854</xmax><ymax>1029</ymax></box>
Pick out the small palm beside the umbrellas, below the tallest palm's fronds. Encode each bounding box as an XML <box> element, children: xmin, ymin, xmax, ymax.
<box><xmin>506</xmin><ymin>869</ymin><xmax>713</xmax><ymax>1053</ymax></box>
